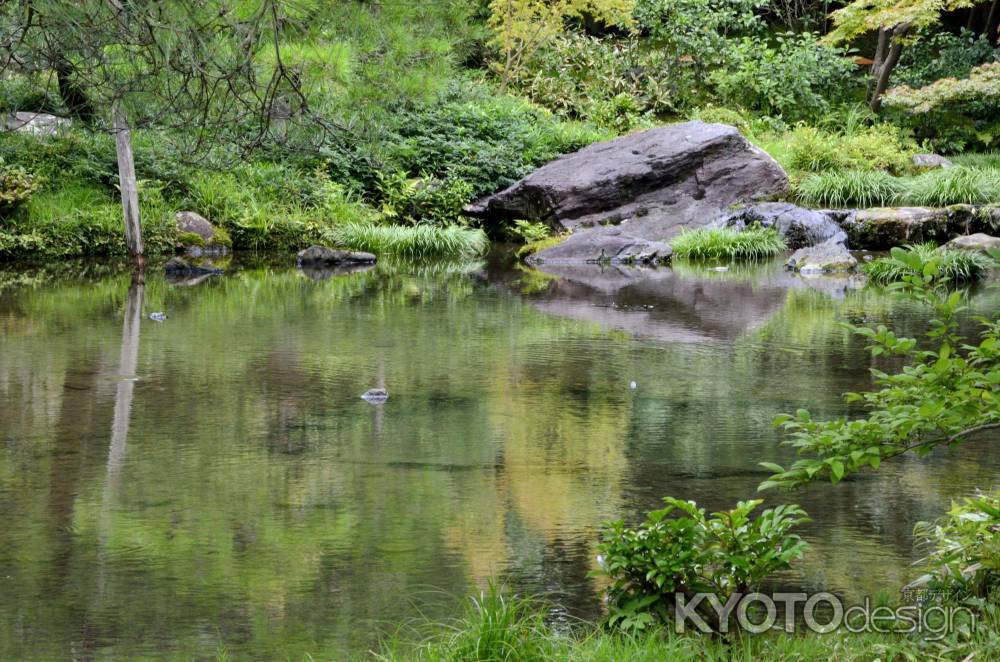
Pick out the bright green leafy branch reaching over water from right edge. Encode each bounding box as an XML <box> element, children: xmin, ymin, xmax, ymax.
<box><xmin>759</xmin><ymin>251</ymin><xmax>1000</xmax><ymax>490</ymax></box>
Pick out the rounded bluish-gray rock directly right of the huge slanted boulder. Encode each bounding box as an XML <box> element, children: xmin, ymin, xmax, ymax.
<box><xmin>720</xmin><ymin>202</ymin><xmax>847</xmax><ymax>249</ymax></box>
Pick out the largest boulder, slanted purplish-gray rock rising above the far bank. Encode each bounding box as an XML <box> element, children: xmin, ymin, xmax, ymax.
<box><xmin>466</xmin><ymin>122</ymin><xmax>788</xmax><ymax>259</ymax></box>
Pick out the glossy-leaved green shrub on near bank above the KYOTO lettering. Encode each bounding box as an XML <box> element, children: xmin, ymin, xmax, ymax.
<box><xmin>598</xmin><ymin>497</ymin><xmax>809</xmax><ymax>632</ymax></box>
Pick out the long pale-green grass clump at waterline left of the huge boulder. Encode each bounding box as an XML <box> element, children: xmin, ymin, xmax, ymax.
<box><xmin>323</xmin><ymin>223</ymin><xmax>489</xmax><ymax>259</ymax></box>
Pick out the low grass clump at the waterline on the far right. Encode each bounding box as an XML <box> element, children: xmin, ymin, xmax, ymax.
<box><xmin>864</xmin><ymin>244</ymin><xmax>995</xmax><ymax>285</ymax></box>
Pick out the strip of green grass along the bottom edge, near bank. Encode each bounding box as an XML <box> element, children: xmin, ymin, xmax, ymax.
<box><xmin>375</xmin><ymin>586</ymin><xmax>1000</xmax><ymax>662</ymax></box>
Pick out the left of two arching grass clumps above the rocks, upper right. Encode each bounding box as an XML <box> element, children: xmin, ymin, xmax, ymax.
<box><xmin>797</xmin><ymin>170</ymin><xmax>906</xmax><ymax>208</ymax></box>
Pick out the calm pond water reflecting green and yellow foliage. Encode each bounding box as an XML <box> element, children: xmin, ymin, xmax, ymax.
<box><xmin>0</xmin><ymin>258</ymin><xmax>1000</xmax><ymax>659</ymax></box>
